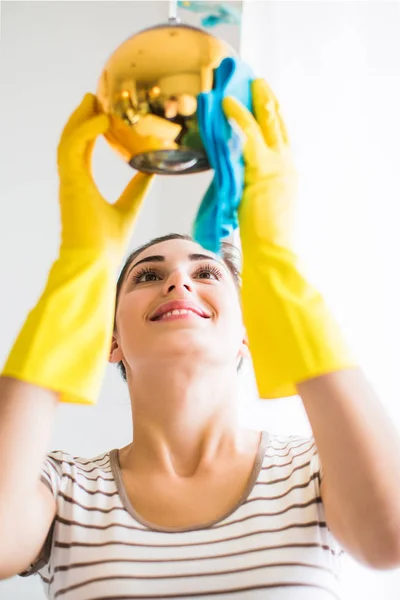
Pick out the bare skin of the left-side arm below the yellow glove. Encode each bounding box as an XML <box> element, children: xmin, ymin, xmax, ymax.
<box><xmin>0</xmin><ymin>377</ymin><xmax>58</xmax><ymax>579</ymax></box>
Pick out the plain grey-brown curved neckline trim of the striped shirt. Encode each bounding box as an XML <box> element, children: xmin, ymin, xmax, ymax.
<box><xmin>110</xmin><ymin>431</ymin><xmax>269</xmax><ymax>533</ymax></box>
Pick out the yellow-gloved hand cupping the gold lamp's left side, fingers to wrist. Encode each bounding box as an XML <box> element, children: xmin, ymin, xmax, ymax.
<box><xmin>57</xmin><ymin>94</ymin><xmax>153</xmax><ymax>263</ymax></box>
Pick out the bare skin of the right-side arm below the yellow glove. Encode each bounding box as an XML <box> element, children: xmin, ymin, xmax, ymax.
<box><xmin>297</xmin><ymin>369</ymin><xmax>400</xmax><ymax>568</ymax></box>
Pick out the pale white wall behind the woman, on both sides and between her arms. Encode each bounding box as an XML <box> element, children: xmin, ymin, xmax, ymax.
<box><xmin>0</xmin><ymin>0</ymin><xmax>400</xmax><ymax>600</ymax></box>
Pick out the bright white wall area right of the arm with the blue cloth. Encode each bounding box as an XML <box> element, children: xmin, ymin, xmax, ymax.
<box><xmin>242</xmin><ymin>0</ymin><xmax>400</xmax><ymax>600</ymax></box>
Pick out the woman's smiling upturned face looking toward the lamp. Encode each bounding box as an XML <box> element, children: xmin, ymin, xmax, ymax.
<box><xmin>110</xmin><ymin>239</ymin><xmax>247</xmax><ymax>373</ymax></box>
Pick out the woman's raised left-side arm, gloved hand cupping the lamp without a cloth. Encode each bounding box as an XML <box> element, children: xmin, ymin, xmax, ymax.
<box><xmin>0</xmin><ymin>94</ymin><xmax>151</xmax><ymax>578</ymax></box>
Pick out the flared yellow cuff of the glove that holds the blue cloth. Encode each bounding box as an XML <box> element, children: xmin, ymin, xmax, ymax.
<box><xmin>242</xmin><ymin>246</ymin><xmax>356</xmax><ymax>398</ymax></box>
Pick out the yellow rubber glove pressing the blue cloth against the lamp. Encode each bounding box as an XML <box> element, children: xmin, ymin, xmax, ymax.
<box><xmin>223</xmin><ymin>79</ymin><xmax>355</xmax><ymax>398</ymax></box>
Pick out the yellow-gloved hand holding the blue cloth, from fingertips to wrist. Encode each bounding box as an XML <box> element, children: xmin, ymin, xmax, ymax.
<box><xmin>223</xmin><ymin>79</ymin><xmax>297</xmax><ymax>251</ymax></box>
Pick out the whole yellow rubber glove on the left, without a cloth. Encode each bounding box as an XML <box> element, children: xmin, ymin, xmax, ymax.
<box><xmin>2</xmin><ymin>94</ymin><xmax>152</xmax><ymax>404</ymax></box>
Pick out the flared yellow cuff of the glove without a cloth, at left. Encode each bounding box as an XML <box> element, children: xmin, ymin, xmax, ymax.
<box><xmin>2</xmin><ymin>250</ymin><xmax>115</xmax><ymax>404</ymax></box>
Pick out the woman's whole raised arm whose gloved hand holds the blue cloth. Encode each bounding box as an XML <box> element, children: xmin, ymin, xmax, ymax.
<box><xmin>224</xmin><ymin>80</ymin><xmax>400</xmax><ymax>568</ymax></box>
